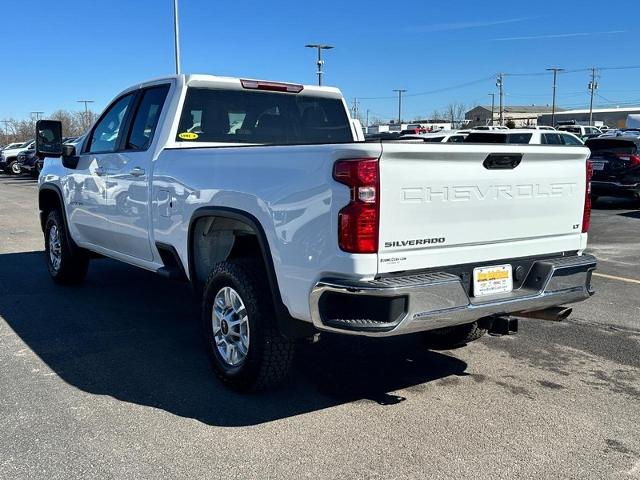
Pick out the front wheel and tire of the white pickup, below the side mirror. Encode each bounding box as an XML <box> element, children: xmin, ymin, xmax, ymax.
<box><xmin>44</xmin><ymin>210</ymin><xmax>89</xmax><ymax>285</ymax></box>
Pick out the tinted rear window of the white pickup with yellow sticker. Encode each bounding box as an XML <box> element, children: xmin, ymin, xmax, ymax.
<box><xmin>176</xmin><ymin>87</ymin><xmax>353</xmax><ymax>145</ymax></box>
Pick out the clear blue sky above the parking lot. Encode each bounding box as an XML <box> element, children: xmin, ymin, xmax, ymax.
<box><xmin>0</xmin><ymin>0</ymin><xmax>640</xmax><ymax>120</ymax></box>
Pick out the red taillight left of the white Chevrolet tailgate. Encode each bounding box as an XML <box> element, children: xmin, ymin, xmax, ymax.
<box><xmin>333</xmin><ymin>158</ymin><xmax>380</xmax><ymax>253</ymax></box>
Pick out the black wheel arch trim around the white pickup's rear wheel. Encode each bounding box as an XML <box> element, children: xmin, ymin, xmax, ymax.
<box><xmin>187</xmin><ymin>207</ymin><xmax>316</xmax><ymax>337</ymax></box>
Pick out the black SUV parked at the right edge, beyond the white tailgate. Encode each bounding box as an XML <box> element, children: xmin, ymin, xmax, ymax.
<box><xmin>585</xmin><ymin>136</ymin><xmax>640</xmax><ymax>201</ymax></box>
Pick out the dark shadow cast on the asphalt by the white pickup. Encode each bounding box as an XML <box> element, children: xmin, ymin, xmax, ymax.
<box><xmin>0</xmin><ymin>252</ymin><xmax>467</xmax><ymax>426</ymax></box>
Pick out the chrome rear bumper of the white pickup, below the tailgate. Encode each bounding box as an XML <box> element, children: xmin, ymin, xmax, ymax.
<box><xmin>310</xmin><ymin>255</ymin><xmax>596</xmax><ymax>337</ymax></box>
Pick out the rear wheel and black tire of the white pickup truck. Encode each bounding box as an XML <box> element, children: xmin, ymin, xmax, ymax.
<box><xmin>202</xmin><ymin>259</ymin><xmax>295</xmax><ymax>392</ymax></box>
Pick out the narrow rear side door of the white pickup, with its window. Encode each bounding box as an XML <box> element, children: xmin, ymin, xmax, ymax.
<box><xmin>105</xmin><ymin>84</ymin><xmax>170</xmax><ymax>261</ymax></box>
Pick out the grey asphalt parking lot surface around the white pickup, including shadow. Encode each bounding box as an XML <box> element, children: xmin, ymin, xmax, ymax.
<box><xmin>0</xmin><ymin>175</ymin><xmax>640</xmax><ymax>479</ymax></box>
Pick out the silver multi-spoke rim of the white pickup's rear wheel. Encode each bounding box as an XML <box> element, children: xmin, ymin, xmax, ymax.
<box><xmin>211</xmin><ymin>287</ymin><xmax>249</xmax><ymax>367</ymax></box>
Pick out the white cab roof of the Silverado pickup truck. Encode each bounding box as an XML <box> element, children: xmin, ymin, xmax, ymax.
<box><xmin>127</xmin><ymin>73</ymin><xmax>342</xmax><ymax>98</ymax></box>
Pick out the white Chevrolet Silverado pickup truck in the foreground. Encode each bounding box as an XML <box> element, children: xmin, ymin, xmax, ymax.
<box><xmin>36</xmin><ymin>75</ymin><xmax>596</xmax><ymax>390</ymax></box>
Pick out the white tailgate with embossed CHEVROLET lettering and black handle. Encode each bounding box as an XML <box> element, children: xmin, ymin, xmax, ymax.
<box><xmin>378</xmin><ymin>143</ymin><xmax>589</xmax><ymax>273</ymax></box>
